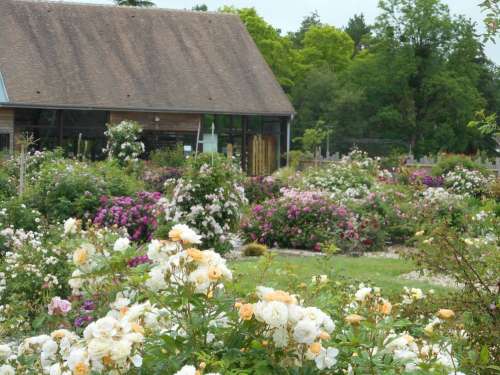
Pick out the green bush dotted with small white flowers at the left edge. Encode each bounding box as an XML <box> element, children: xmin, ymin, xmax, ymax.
<box><xmin>0</xmin><ymin>228</ymin><xmax>71</xmax><ymax>337</ymax></box>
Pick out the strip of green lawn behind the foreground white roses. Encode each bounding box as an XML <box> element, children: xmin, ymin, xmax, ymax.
<box><xmin>230</xmin><ymin>255</ymin><xmax>447</xmax><ymax>295</ymax></box>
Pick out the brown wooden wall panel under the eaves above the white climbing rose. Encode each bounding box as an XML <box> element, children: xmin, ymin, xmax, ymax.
<box><xmin>109</xmin><ymin>112</ymin><xmax>201</xmax><ymax>132</ymax></box>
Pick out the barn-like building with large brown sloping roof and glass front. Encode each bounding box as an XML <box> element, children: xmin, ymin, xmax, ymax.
<box><xmin>0</xmin><ymin>0</ymin><xmax>294</xmax><ymax>174</ymax></box>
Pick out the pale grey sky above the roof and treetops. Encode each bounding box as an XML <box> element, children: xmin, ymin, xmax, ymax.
<box><xmin>65</xmin><ymin>0</ymin><xmax>500</xmax><ymax>65</ymax></box>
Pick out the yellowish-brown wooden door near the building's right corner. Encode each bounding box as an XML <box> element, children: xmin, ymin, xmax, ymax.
<box><xmin>249</xmin><ymin>135</ymin><xmax>277</xmax><ymax>176</ymax></box>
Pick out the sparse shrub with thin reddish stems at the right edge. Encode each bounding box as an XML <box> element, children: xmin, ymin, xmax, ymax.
<box><xmin>411</xmin><ymin>210</ymin><xmax>500</xmax><ymax>361</ymax></box>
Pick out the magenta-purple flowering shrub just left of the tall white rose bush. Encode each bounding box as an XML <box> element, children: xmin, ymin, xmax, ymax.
<box><xmin>94</xmin><ymin>192</ymin><xmax>161</xmax><ymax>241</ymax></box>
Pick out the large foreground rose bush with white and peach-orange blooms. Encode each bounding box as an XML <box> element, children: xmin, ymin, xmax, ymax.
<box><xmin>0</xmin><ymin>226</ymin><xmax>495</xmax><ymax>375</ymax></box>
